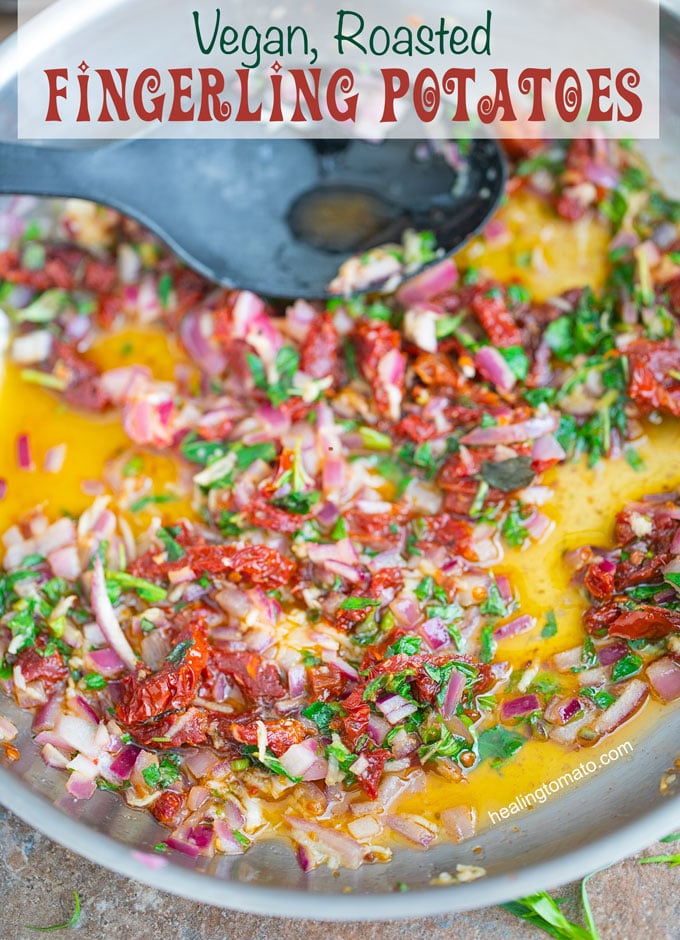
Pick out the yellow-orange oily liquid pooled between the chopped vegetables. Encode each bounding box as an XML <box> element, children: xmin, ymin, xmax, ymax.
<box><xmin>0</xmin><ymin>194</ymin><xmax>680</xmax><ymax>844</ymax></box>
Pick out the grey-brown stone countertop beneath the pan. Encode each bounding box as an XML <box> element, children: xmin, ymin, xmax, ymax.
<box><xmin>0</xmin><ymin>9</ymin><xmax>680</xmax><ymax>940</ymax></box>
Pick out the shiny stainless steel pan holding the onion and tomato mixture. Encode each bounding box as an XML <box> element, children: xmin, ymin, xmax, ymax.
<box><xmin>0</xmin><ymin>0</ymin><xmax>680</xmax><ymax>920</ymax></box>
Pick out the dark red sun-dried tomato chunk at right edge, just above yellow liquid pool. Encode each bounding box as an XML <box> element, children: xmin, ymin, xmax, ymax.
<box><xmin>626</xmin><ymin>339</ymin><xmax>680</xmax><ymax>415</ymax></box>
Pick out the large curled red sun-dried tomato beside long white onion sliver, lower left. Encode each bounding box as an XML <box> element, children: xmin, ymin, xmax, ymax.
<box><xmin>116</xmin><ymin>620</ymin><xmax>208</xmax><ymax>725</ymax></box>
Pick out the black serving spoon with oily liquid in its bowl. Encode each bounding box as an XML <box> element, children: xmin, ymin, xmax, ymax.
<box><xmin>0</xmin><ymin>139</ymin><xmax>506</xmax><ymax>299</ymax></box>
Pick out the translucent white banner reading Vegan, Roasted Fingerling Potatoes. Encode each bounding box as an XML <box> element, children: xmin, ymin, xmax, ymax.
<box><xmin>18</xmin><ymin>0</ymin><xmax>659</xmax><ymax>139</ymax></box>
